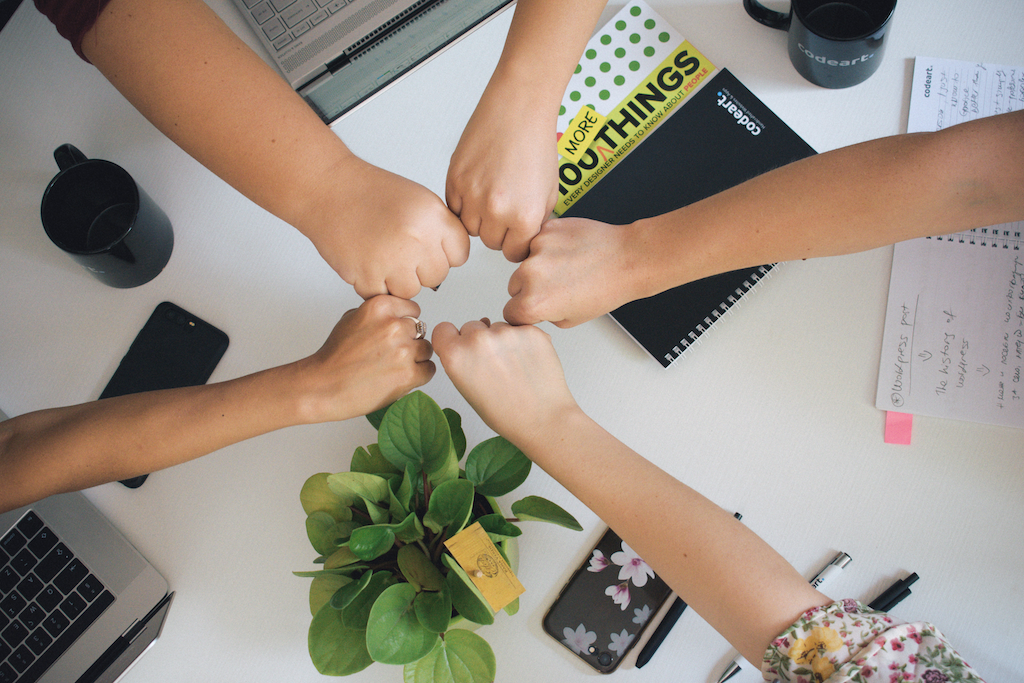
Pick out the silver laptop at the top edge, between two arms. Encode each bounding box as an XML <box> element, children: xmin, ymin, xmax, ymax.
<box><xmin>233</xmin><ymin>0</ymin><xmax>513</xmax><ymax>124</ymax></box>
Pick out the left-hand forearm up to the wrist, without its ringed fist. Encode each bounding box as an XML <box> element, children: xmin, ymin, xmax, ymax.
<box><xmin>0</xmin><ymin>366</ymin><xmax>310</xmax><ymax>510</ymax></box>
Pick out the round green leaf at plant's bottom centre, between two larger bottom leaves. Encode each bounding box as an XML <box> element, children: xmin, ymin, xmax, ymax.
<box><xmin>367</xmin><ymin>584</ymin><xmax>438</xmax><ymax>664</ymax></box>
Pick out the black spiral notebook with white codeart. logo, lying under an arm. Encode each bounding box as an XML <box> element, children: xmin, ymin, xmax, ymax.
<box><xmin>562</xmin><ymin>69</ymin><xmax>815</xmax><ymax>368</ymax></box>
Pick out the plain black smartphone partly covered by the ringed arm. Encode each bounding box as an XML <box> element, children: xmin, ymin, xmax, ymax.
<box><xmin>99</xmin><ymin>301</ymin><xmax>227</xmax><ymax>488</ymax></box>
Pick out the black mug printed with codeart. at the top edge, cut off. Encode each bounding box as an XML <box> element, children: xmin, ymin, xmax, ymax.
<box><xmin>743</xmin><ymin>0</ymin><xmax>896</xmax><ymax>88</ymax></box>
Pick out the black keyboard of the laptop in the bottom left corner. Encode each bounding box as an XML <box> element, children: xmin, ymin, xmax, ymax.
<box><xmin>0</xmin><ymin>511</ymin><xmax>114</xmax><ymax>683</ymax></box>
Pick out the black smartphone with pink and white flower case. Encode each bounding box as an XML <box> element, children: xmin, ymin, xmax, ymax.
<box><xmin>544</xmin><ymin>528</ymin><xmax>672</xmax><ymax>674</ymax></box>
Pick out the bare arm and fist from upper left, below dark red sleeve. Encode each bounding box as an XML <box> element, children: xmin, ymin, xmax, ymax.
<box><xmin>82</xmin><ymin>0</ymin><xmax>469</xmax><ymax>298</ymax></box>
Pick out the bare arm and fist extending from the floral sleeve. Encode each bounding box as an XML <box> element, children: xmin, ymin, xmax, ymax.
<box><xmin>433</xmin><ymin>322</ymin><xmax>830</xmax><ymax>661</ymax></box>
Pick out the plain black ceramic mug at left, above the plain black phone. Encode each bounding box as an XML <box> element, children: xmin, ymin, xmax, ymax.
<box><xmin>40</xmin><ymin>144</ymin><xmax>174</xmax><ymax>288</ymax></box>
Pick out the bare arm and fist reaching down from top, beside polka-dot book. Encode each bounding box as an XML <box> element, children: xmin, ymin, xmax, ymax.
<box><xmin>445</xmin><ymin>0</ymin><xmax>605</xmax><ymax>261</ymax></box>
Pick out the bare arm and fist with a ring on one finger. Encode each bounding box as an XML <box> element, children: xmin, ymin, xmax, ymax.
<box><xmin>0</xmin><ymin>297</ymin><xmax>434</xmax><ymax>511</ymax></box>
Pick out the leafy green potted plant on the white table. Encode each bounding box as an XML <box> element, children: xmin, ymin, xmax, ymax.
<box><xmin>295</xmin><ymin>391</ymin><xmax>581</xmax><ymax>683</ymax></box>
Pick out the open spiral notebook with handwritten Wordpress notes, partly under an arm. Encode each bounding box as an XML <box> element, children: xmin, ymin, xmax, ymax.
<box><xmin>876</xmin><ymin>57</ymin><xmax>1024</xmax><ymax>428</ymax></box>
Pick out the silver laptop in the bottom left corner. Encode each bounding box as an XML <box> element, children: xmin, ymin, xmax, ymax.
<box><xmin>0</xmin><ymin>414</ymin><xmax>174</xmax><ymax>683</ymax></box>
